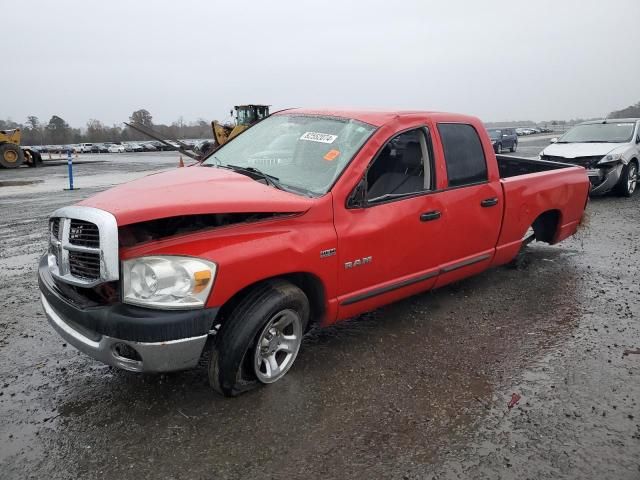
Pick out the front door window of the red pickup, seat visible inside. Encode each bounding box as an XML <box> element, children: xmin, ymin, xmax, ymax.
<box><xmin>367</xmin><ymin>128</ymin><xmax>433</xmax><ymax>202</ymax></box>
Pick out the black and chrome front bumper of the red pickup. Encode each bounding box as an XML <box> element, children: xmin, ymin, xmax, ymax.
<box><xmin>38</xmin><ymin>257</ymin><xmax>218</xmax><ymax>372</ymax></box>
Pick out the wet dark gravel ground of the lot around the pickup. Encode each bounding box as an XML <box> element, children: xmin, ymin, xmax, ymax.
<box><xmin>0</xmin><ymin>143</ymin><xmax>640</xmax><ymax>480</ymax></box>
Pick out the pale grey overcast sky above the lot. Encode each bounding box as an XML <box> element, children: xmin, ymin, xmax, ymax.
<box><xmin>5</xmin><ymin>0</ymin><xmax>640</xmax><ymax>127</ymax></box>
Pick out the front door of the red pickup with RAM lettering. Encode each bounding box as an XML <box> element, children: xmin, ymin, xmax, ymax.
<box><xmin>334</xmin><ymin>127</ymin><xmax>442</xmax><ymax>318</ymax></box>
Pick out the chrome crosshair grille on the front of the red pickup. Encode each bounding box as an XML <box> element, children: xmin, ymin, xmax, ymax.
<box><xmin>48</xmin><ymin>206</ymin><xmax>119</xmax><ymax>287</ymax></box>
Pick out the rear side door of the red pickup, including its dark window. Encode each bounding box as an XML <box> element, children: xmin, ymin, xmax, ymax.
<box><xmin>436</xmin><ymin>123</ymin><xmax>504</xmax><ymax>287</ymax></box>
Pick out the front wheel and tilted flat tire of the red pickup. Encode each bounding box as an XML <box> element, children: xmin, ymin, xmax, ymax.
<box><xmin>208</xmin><ymin>280</ymin><xmax>310</xmax><ymax>397</ymax></box>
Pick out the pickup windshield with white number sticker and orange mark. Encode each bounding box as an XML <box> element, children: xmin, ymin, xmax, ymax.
<box><xmin>203</xmin><ymin>114</ymin><xmax>375</xmax><ymax>195</ymax></box>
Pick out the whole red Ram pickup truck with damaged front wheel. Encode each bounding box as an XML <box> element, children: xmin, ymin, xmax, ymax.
<box><xmin>39</xmin><ymin>110</ymin><xmax>589</xmax><ymax>395</ymax></box>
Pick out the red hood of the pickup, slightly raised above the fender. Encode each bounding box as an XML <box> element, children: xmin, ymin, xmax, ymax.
<box><xmin>79</xmin><ymin>166</ymin><xmax>313</xmax><ymax>226</ymax></box>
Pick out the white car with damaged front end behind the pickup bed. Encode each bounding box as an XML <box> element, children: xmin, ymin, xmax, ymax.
<box><xmin>540</xmin><ymin>118</ymin><xmax>640</xmax><ymax>197</ymax></box>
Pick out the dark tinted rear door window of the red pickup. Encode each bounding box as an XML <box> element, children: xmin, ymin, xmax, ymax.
<box><xmin>438</xmin><ymin>123</ymin><xmax>488</xmax><ymax>187</ymax></box>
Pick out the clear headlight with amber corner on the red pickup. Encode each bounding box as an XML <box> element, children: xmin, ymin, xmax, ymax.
<box><xmin>122</xmin><ymin>256</ymin><xmax>216</xmax><ymax>310</ymax></box>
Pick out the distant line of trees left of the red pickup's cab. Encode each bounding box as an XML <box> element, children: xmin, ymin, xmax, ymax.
<box><xmin>0</xmin><ymin>109</ymin><xmax>213</xmax><ymax>145</ymax></box>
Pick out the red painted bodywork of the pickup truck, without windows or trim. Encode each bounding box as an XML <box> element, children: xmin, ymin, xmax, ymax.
<box><xmin>82</xmin><ymin>110</ymin><xmax>589</xmax><ymax>324</ymax></box>
